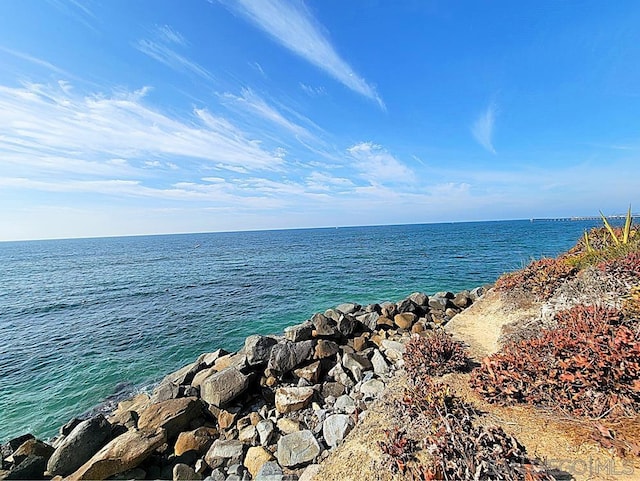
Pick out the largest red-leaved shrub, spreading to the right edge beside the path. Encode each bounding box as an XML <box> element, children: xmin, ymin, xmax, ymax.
<box><xmin>470</xmin><ymin>306</ymin><xmax>640</xmax><ymax>417</ymax></box>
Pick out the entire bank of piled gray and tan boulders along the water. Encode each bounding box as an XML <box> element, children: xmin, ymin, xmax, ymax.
<box><xmin>0</xmin><ymin>287</ymin><xmax>485</xmax><ymax>481</ymax></box>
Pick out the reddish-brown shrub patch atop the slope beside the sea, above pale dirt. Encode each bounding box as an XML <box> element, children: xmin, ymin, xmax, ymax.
<box><xmin>495</xmin><ymin>257</ymin><xmax>578</xmax><ymax>299</ymax></box>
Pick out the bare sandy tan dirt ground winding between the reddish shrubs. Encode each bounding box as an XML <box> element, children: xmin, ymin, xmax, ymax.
<box><xmin>314</xmin><ymin>291</ymin><xmax>640</xmax><ymax>481</ymax></box>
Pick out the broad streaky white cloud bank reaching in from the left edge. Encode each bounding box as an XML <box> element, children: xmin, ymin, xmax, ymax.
<box><xmin>0</xmin><ymin>84</ymin><xmax>282</xmax><ymax>172</ymax></box>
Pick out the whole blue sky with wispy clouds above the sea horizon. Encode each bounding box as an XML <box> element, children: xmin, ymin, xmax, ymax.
<box><xmin>0</xmin><ymin>0</ymin><xmax>640</xmax><ymax>240</ymax></box>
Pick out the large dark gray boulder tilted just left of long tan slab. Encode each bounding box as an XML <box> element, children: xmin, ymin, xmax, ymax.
<box><xmin>47</xmin><ymin>414</ymin><xmax>111</xmax><ymax>476</ymax></box>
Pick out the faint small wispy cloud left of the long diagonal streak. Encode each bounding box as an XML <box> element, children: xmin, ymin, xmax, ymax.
<box><xmin>134</xmin><ymin>25</ymin><xmax>213</xmax><ymax>80</ymax></box>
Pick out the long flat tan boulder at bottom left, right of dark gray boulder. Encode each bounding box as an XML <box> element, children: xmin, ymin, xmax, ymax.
<box><xmin>66</xmin><ymin>429</ymin><xmax>167</xmax><ymax>481</ymax></box>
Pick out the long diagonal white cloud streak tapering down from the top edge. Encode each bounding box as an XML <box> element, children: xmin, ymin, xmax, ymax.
<box><xmin>221</xmin><ymin>0</ymin><xmax>385</xmax><ymax>109</ymax></box>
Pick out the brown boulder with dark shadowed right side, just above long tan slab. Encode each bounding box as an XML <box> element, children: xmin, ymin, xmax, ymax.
<box><xmin>138</xmin><ymin>397</ymin><xmax>203</xmax><ymax>439</ymax></box>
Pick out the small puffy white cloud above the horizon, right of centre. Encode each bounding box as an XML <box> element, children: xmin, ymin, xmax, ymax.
<box><xmin>347</xmin><ymin>142</ymin><xmax>416</xmax><ymax>185</ymax></box>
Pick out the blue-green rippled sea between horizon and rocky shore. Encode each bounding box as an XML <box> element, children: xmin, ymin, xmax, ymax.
<box><xmin>0</xmin><ymin>221</ymin><xmax>596</xmax><ymax>440</ymax></box>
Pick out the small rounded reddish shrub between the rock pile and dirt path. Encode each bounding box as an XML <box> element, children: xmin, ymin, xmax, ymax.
<box><xmin>403</xmin><ymin>329</ymin><xmax>468</xmax><ymax>378</ymax></box>
